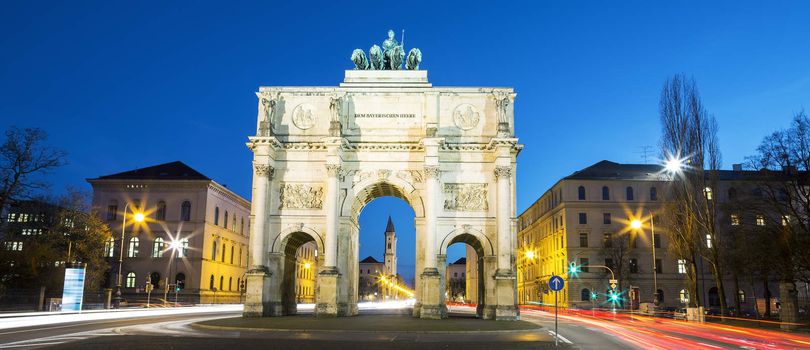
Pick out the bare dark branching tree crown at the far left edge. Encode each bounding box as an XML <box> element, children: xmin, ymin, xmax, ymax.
<box><xmin>0</xmin><ymin>127</ymin><xmax>65</xmax><ymax>210</ymax></box>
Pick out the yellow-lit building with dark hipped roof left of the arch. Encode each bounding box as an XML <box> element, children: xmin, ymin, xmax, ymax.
<box><xmin>87</xmin><ymin>162</ymin><xmax>250</xmax><ymax>303</ymax></box>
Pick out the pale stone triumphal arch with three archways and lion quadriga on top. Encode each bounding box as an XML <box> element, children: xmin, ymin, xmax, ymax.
<box><xmin>244</xmin><ymin>36</ymin><xmax>522</xmax><ymax>320</ymax></box>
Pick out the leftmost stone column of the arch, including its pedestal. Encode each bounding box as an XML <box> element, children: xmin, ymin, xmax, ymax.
<box><xmin>242</xmin><ymin>164</ymin><xmax>277</xmax><ymax>317</ymax></box>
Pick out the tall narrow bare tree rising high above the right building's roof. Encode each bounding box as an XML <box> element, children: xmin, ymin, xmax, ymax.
<box><xmin>659</xmin><ymin>75</ymin><xmax>727</xmax><ymax>315</ymax></box>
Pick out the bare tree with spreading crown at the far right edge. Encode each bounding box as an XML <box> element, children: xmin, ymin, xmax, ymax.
<box><xmin>748</xmin><ymin>111</ymin><xmax>810</xmax><ymax>329</ymax></box>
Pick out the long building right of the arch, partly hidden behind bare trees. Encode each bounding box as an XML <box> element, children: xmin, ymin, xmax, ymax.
<box><xmin>518</xmin><ymin>161</ymin><xmax>776</xmax><ymax>310</ymax></box>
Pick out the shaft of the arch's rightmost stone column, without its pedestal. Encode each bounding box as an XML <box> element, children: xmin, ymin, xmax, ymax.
<box><xmin>495</xmin><ymin>166</ymin><xmax>513</xmax><ymax>275</ymax></box>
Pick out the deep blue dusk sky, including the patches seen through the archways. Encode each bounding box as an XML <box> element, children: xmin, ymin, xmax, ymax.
<box><xmin>0</xmin><ymin>1</ymin><xmax>810</xmax><ymax>284</ymax></box>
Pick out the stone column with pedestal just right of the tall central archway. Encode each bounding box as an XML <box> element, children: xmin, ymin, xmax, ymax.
<box><xmin>419</xmin><ymin>166</ymin><xmax>447</xmax><ymax>319</ymax></box>
